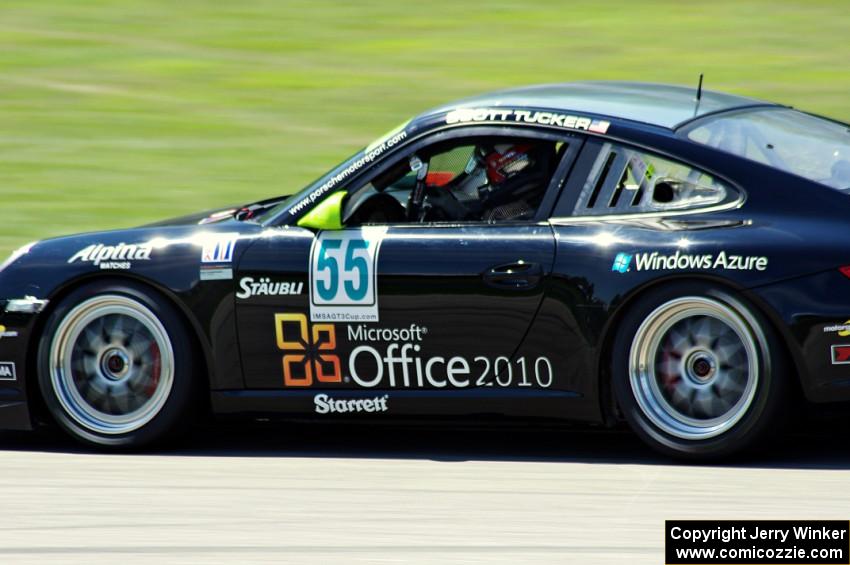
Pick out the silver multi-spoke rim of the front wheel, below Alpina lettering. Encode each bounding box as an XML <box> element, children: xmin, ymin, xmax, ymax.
<box><xmin>50</xmin><ymin>295</ymin><xmax>174</xmax><ymax>435</ymax></box>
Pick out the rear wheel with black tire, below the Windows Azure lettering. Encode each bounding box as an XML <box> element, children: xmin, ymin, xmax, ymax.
<box><xmin>611</xmin><ymin>282</ymin><xmax>791</xmax><ymax>460</ymax></box>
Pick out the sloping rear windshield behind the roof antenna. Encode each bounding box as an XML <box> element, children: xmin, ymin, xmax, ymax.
<box><xmin>686</xmin><ymin>108</ymin><xmax>850</xmax><ymax>191</ymax></box>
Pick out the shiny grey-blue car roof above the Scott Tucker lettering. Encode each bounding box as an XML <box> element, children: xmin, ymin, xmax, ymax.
<box><xmin>425</xmin><ymin>81</ymin><xmax>778</xmax><ymax>129</ymax></box>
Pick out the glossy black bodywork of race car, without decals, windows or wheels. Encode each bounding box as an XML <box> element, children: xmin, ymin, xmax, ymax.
<box><xmin>0</xmin><ymin>81</ymin><xmax>850</xmax><ymax>429</ymax></box>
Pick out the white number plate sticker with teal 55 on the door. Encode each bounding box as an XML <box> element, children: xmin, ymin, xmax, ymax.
<box><xmin>309</xmin><ymin>226</ymin><xmax>387</xmax><ymax>322</ymax></box>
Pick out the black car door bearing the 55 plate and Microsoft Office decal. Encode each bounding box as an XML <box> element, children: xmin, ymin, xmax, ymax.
<box><xmin>229</xmin><ymin>129</ymin><xmax>580</xmax><ymax>413</ymax></box>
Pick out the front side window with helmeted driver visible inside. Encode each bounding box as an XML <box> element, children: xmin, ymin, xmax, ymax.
<box><xmin>343</xmin><ymin>137</ymin><xmax>567</xmax><ymax>226</ymax></box>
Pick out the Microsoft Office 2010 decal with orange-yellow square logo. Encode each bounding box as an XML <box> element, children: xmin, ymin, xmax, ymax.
<box><xmin>274</xmin><ymin>313</ymin><xmax>554</xmax><ymax>389</ymax></box>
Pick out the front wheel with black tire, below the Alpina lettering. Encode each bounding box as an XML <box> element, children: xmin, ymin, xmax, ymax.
<box><xmin>38</xmin><ymin>281</ymin><xmax>198</xmax><ymax>449</ymax></box>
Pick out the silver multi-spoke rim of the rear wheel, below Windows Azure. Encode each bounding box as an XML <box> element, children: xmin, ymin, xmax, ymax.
<box><xmin>629</xmin><ymin>296</ymin><xmax>764</xmax><ymax>440</ymax></box>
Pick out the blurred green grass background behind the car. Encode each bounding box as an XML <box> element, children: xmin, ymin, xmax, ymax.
<box><xmin>0</xmin><ymin>0</ymin><xmax>850</xmax><ymax>255</ymax></box>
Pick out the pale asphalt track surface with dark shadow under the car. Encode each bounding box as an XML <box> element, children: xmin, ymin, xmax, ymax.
<box><xmin>0</xmin><ymin>416</ymin><xmax>850</xmax><ymax>565</ymax></box>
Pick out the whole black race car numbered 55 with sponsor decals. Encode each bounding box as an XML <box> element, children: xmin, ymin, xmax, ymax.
<box><xmin>0</xmin><ymin>83</ymin><xmax>850</xmax><ymax>457</ymax></box>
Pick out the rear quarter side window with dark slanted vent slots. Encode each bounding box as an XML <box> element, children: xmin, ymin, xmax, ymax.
<box><xmin>574</xmin><ymin>143</ymin><xmax>740</xmax><ymax>216</ymax></box>
